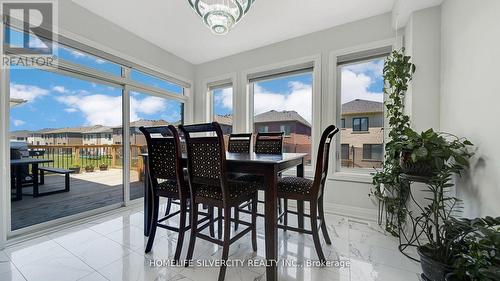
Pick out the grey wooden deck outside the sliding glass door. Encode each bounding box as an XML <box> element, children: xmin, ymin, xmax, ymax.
<box><xmin>11</xmin><ymin>169</ymin><xmax>144</xmax><ymax>230</ymax></box>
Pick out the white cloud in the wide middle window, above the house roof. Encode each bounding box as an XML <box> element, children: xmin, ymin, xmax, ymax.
<box><xmin>254</xmin><ymin>81</ymin><xmax>312</xmax><ymax>122</ymax></box>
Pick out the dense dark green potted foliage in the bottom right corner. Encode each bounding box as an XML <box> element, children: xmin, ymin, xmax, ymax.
<box><xmin>445</xmin><ymin>217</ymin><xmax>500</xmax><ymax>281</ymax></box>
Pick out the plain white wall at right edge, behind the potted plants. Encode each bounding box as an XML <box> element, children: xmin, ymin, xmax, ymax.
<box><xmin>440</xmin><ymin>0</ymin><xmax>500</xmax><ymax>216</ymax></box>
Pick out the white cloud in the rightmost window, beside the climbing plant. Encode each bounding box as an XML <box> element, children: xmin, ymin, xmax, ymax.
<box><xmin>341</xmin><ymin>68</ymin><xmax>384</xmax><ymax>104</ymax></box>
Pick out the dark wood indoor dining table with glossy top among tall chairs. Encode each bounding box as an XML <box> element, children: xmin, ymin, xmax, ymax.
<box><xmin>141</xmin><ymin>152</ymin><xmax>307</xmax><ymax>281</ymax></box>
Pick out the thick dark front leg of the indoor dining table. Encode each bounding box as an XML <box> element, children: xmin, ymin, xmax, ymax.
<box><xmin>265</xmin><ymin>168</ymin><xmax>278</xmax><ymax>281</ymax></box>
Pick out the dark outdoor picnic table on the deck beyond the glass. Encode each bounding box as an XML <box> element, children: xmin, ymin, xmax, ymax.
<box><xmin>10</xmin><ymin>157</ymin><xmax>54</xmax><ymax>201</ymax></box>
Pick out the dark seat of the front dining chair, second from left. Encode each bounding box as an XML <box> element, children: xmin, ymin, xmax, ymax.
<box><xmin>196</xmin><ymin>180</ymin><xmax>259</xmax><ymax>200</ymax></box>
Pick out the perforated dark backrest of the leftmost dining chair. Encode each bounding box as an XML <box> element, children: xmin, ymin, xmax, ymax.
<box><xmin>139</xmin><ymin>125</ymin><xmax>187</xmax><ymax>197</ymax></box>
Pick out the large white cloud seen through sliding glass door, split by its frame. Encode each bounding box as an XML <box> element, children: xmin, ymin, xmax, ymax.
<box><xmin>56</xmin><ymin>94</ymin><xmax>166</xmax><ymax>126</ymax></box>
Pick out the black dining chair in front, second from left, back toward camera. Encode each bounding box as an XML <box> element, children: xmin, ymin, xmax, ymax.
<box><xmin>179</xmin><ymin>122</ymin><xmax>258</xmax><ymax>281</ymax></box>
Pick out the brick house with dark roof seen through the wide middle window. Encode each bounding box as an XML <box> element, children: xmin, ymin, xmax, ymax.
<box><xmin>254</xmin><ymin>110</ymin><xmax>312</xmax><ymax>161</ymax></box>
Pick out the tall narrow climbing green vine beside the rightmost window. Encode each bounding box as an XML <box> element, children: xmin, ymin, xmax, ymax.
<box><xmin>371</xmin><ymin>48</ymin><xmax>415</xmax><ymax>236</ymax></box>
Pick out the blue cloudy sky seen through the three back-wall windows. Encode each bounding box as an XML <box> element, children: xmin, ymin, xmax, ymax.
<box><xmin>214</xmin><ymin>59</ymin><xmax>384</xmax><ymax>123</ymax></box>
